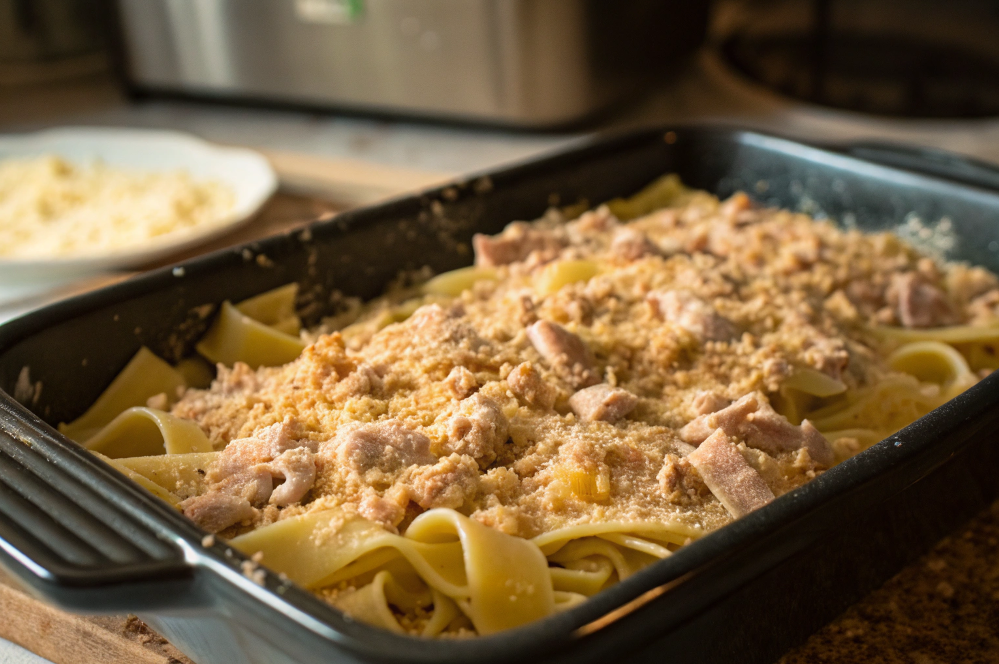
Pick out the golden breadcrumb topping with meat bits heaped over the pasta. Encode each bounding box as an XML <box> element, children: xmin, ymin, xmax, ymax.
<box><xmin>173</xmin><ymin>185</ymin><xmax>999</xmax><ymax>537</ymax></box>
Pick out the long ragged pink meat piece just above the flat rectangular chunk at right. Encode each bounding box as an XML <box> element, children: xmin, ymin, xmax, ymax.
<box><xmin>680</xmin><ymin>393</ymin><xmax>834</xmax><ymax>466</ymax></box>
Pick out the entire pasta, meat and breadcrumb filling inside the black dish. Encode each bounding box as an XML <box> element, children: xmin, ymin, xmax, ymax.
<box><xmin>60</xmin><ymin>176</ymin><xmax>999</xmax><ymax>636</ymax></box>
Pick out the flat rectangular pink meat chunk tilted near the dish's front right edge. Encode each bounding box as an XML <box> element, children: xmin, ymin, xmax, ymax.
<box><xmin>686</xmin><ymin>429</ymin><xmax>774</xmax><ymax>519</ymax></box>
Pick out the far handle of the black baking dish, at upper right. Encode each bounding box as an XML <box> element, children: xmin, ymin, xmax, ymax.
<box><xmin>833</xmin><ymin>141</ymin><xmax>999</xmax><ymax>191</ymax></box>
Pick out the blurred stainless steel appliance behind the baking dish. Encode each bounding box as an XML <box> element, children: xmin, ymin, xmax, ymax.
<box><xmin>118</xmin><ymin>0</ymin><xmax>708</xmax><ymax>127</ymax></box>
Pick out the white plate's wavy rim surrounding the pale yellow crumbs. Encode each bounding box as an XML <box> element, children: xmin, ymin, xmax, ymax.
<box><xmin>0</xmin><ymin>127</ymin><xmax>277</xmax><ymax>290</ymax></box>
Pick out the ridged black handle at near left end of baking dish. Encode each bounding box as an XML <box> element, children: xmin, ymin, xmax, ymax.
<box><xmin>0</xmin><ymin>392</ymin><xmax>194</xmax><ymax>613</ymax></box>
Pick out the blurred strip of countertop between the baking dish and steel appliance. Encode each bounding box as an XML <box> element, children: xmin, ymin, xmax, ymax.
<box><xmin>9</xmin><ymin>51</ymin><xmax>999</xmax><ymax>175</ymax></box>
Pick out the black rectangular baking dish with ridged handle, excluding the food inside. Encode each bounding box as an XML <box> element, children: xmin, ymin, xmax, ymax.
<box><xmin>0</xmin><ymin>127</ymin><xmax>999</xmax><ymax>664</ymax></box>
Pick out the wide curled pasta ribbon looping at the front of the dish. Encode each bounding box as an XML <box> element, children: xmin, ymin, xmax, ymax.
<box><xmin>232</xmin><ymin>509</ymin><xmax>555</xmax><ymax>634</ymax></box>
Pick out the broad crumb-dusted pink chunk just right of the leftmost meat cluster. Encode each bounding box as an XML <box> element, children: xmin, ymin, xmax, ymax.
<box><xmin>330</xmin><ymin>420</ymin><xmax>437</xmax><ymax>475</ymax></box>
